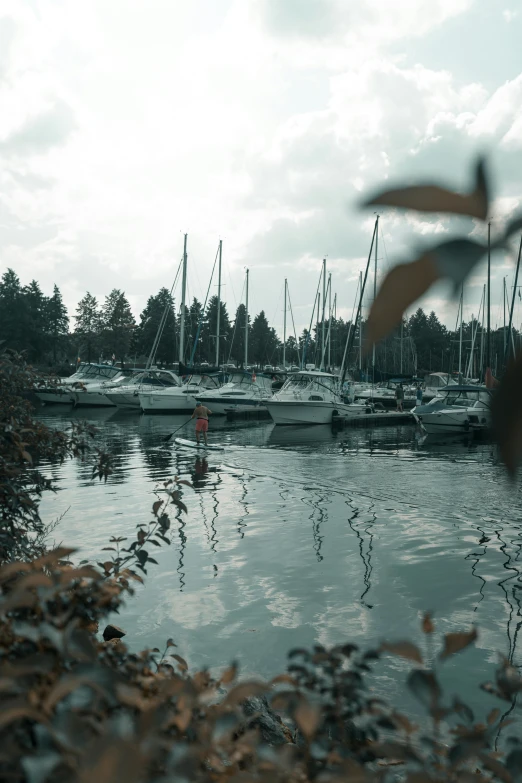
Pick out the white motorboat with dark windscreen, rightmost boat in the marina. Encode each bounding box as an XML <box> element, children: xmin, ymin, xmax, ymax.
<box><xmin>413</xmin><ymin>384</ymin><xmax>492</xmax><ymax>433</ymax></box>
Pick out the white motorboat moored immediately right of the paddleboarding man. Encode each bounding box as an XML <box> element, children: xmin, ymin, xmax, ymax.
<box><xmin>196</xmin><ymin>372</ymin><xmax>273</xmax><ymax>416</ymax></box>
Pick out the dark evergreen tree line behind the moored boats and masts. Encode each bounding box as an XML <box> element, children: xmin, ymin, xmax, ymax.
<box><xmin>0</xmin><ymin>269</ymin><xmax>520</xmax><ymax>378</ymax></box>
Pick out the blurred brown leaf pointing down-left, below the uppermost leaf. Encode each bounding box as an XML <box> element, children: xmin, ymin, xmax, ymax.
<box><xmin>366</xmin><ymin>253</ymin><xmax>439</xmax><ymax>350</ymax></box>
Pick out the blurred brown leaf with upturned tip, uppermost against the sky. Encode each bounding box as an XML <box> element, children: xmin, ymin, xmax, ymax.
<box><xmin>362</xmin><ymin>158</ymin><xmax>488</xmax><ymax>220</ymax></box>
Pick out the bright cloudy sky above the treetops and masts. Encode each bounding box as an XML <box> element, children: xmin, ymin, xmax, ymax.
<box><xmin>0</xmin><ymin>0</ymin><xmax>522</xmax><ymax>340</ymax></box>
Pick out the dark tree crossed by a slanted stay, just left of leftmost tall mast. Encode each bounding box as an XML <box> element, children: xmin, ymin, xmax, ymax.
<box><xmin>132</xmin><ymin>288</ymin><xmax>176</xmax><ymax>364</ymax></box>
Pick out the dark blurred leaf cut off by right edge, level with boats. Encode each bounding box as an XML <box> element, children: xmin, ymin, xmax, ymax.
<box><xmin>491</xmin><ymin>354</ymin><xmax>522</xmax><ymax>478</ymax></box>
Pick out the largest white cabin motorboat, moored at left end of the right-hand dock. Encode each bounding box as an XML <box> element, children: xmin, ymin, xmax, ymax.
<box><xmin>265</xmin><ymin>370</ymin><xmax>371</xmax><ymax>424</ymax></box>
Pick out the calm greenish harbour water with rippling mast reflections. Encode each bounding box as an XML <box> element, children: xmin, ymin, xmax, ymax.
<box><xmin>36</xmin><ymin>409</ymin><xmax>522</xmax><ymax>736</ymax></box>
